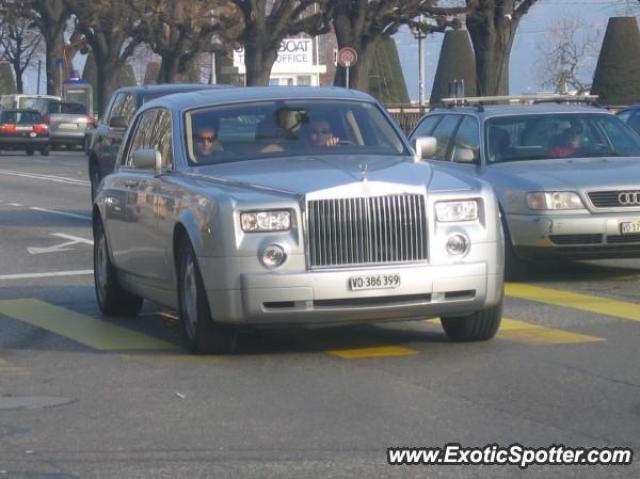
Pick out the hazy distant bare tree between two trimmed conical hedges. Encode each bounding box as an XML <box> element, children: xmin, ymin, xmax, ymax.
<box><xmin>535</xmin><ymin>17</ymin><xmax>602</xmax><ymax>94</ymax></box>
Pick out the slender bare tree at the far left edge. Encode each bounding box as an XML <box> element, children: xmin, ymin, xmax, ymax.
<box><xmin>0</xmin><ymin>0</ymin><xmax>42</xmax><ymax>93</ymax></box>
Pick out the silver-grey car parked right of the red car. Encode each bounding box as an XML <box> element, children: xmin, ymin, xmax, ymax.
<box><xmin>44</xmin><ymin>101</ymin><xmax>93</xmax><ymax>148</ymax></box>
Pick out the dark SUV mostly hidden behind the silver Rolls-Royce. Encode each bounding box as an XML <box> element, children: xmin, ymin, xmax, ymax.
<box><xmin>87</xmin><ymin>83</ymin><xmax>226</xmax><ymax>199</ymax></box>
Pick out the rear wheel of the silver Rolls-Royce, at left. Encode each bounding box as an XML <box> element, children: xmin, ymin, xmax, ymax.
<box><xmin>93</xmin><ymin>220</ymin><xmax>143</xmax><ymax>316</ymax></box>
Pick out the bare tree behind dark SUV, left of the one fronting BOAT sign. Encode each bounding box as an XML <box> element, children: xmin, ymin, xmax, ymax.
<box><xmin>128</xmin><ymin>0</ymin><xmax>244</xmax><ymax>83</ymax></box>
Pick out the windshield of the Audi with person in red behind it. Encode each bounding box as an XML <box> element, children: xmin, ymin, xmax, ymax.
<box><xmin>486</xmin><ymin>113</ymin><xmax>640</xmax><ymax>163</ymax></box>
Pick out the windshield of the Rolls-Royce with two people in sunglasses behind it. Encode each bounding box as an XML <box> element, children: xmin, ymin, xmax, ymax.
<box><xmin>186</xmin><ymin>100</ymin><xmax>408</xmax><ymax>165</ymax></box>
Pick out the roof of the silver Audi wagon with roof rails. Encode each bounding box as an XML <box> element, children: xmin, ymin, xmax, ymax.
<box><xmin>429</xmin><ymin>103</ymin><xmax>609</xmax><ymax>118</ymax></box>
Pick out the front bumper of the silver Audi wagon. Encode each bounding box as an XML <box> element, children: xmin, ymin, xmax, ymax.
<box><xmin>507</xmin><ymin>212</ymin><xmax>640</xmax><ymax>259</ymax></box>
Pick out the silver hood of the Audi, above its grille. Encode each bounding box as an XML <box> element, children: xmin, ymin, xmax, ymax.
<box><xmin>487</xmin><ymin>158</ymin><xmax>640</xmax><ymax>191</ymax></box>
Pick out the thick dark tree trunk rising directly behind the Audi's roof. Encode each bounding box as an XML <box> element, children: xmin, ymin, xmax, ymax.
<box><xmin>466</xmin><ymin>0</ymin><xmax>538</xmax><ymax>96</ymax></box>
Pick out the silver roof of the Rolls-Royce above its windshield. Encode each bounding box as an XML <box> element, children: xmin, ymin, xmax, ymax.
<box><xmin>145</xmin><ymin>86</ymin><xmax>375</xmax><ymax>110</ymax></box>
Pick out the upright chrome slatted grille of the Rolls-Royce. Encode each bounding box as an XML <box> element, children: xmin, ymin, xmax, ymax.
<box><xmin>307</xmin><ymin>194</ymin><xmax>427</xmax><ymax>268</ymax></box>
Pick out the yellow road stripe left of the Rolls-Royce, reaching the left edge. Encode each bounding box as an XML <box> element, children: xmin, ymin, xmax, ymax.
<box><xmin>0</xmin><ymin>299</ymin><xmax>180</xmax><ymax>351</ymax></box>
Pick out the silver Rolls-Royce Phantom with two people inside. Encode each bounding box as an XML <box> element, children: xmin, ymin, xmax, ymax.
<box><xmin>93</xmin><ymin>88</ymin><xmax>504</xmax><ymax>353</ymax></box>
